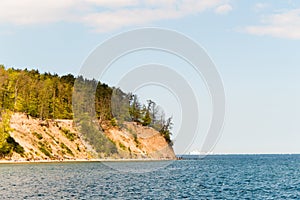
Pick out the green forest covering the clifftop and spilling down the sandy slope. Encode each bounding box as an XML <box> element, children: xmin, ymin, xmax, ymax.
<box><xmin>0</xmin><ymin>65</ymin><xmax>172</xmax><ymax>156</ymax></box>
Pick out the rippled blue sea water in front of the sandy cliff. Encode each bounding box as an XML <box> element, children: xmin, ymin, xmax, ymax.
<box><xmin>0</xmin><ymin>155</ymin><xmax>300</xmax><ymax>199</ymax></box>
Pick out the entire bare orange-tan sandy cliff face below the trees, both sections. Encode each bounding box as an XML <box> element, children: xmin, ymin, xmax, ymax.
<box><xmin>7</xmin><ymin>113</ymin><xmax>175</xmax><ymax>160</ymax></box>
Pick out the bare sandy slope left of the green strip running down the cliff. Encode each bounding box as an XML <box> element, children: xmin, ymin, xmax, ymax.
<box><xmin>10</xmin><ymin>113</ymin><xmax>91</xmax><ymax>160</ymax></box>
